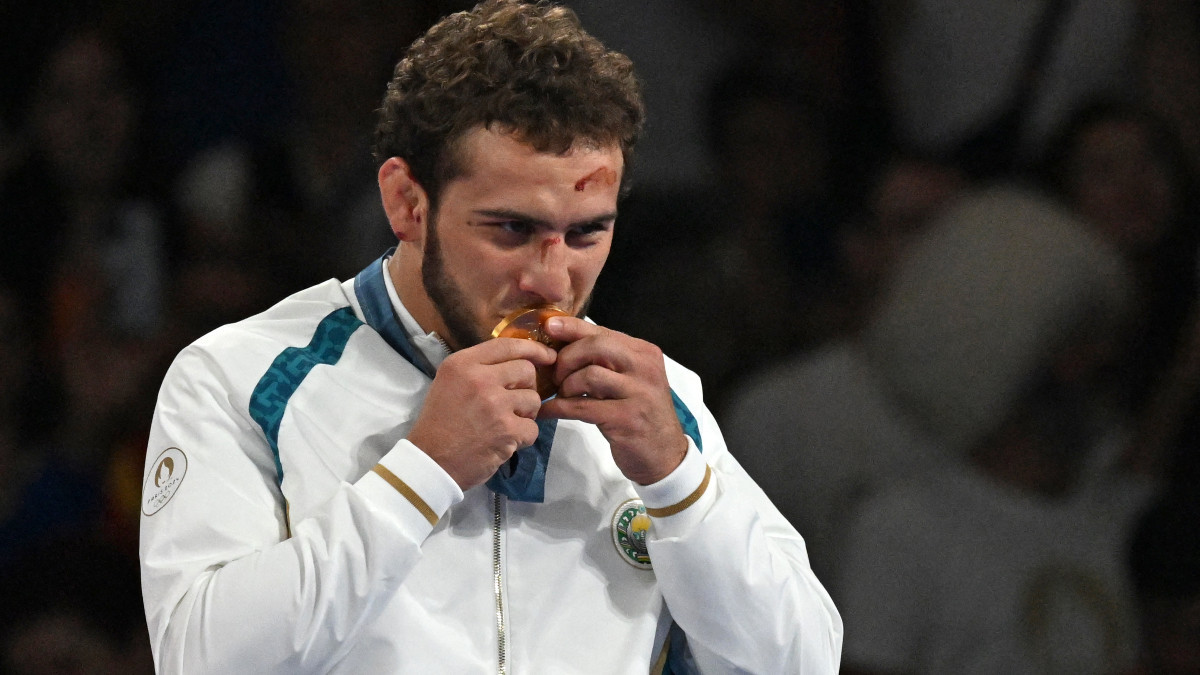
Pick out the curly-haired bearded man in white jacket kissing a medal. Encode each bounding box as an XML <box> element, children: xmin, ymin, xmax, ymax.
<box><xmin>142</xmin><ymin>0</ymin><xmax>841</xmax><ymax>673</ymax></box>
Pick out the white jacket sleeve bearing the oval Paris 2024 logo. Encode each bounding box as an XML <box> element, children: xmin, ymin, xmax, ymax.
<box><xmin>140</xmin><ymin>346</ymin><xmax>462</xmax><ymax>673</ymax></box>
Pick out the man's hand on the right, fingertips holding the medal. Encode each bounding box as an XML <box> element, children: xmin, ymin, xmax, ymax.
<box><xmin>540</xmin><ymin>317</ymin><xmax>688</xmax><ymax>485</ymax></box>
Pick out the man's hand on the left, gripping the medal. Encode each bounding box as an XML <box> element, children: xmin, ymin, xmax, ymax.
<box><xmin>408</xmin><ymin>339</ymin><xmax>556</xmax><ymax>490</ymax></box>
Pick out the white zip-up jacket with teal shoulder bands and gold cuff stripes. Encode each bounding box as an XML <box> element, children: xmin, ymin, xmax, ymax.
<box><xmin>140</xmin><ymin>258</ymin><xmax>841</xmax><ymax>674</ymax></box>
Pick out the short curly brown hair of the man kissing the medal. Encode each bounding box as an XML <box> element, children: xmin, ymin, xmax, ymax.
<box><xmin>374</xmin><ymin>0</ymin><xmax>644</xmax><ymax>203</ymax></box>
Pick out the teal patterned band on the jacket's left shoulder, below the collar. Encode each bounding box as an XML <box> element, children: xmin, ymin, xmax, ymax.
<box><xmin>250</xmin><ymin>307</ymin><xmax>362</xmax><ymax>485</ymax></box>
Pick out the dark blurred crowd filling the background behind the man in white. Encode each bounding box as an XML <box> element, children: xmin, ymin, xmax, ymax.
<box><xmin>0</xmin><ymin>0</ymin><xmax>1200</xmax><ymax>675</ymax></box>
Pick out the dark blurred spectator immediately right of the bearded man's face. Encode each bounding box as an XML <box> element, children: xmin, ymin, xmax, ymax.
<box><xmin>593</xmin><ymin>61</ymin><xmax>848</xmax><ymax>407</ymax></box>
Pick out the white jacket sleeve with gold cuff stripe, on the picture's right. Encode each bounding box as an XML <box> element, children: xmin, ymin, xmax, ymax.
<box><xmin>637</xmin><ymin>362</ymin><xmax>842</xmax><ymax>675</ymax></box>
